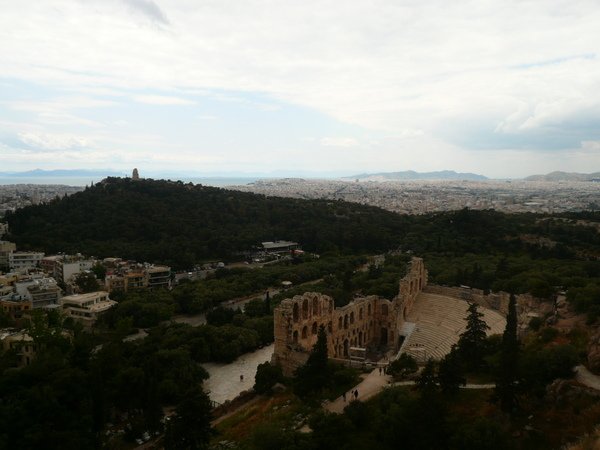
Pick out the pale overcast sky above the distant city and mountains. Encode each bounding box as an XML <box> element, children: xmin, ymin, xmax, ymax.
<box><xmin>0</xmin><ymin>0</ymin><xmax>600</xmax><ymax>177</ymax></box>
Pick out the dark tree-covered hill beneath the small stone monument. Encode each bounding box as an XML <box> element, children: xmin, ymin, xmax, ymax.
<box><xmin>6</xmin><ymin>178</ymin><xmax>406</xmax><ymax>268</ymax></box>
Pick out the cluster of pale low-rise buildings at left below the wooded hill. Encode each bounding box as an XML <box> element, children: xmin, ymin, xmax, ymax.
<box><xmin>0</xmin><ymin>241</ymin><xmax>171</xmax><ymax>326</ymax></box>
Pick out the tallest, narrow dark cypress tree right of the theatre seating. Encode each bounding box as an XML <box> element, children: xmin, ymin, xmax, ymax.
<box><xmin>495</xmin><ymin>294</ymin><xmax>519</xmax><ymax>415</ymax></box>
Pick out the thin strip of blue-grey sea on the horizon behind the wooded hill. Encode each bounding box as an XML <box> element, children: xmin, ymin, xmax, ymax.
<box><xmin>0</xmin><ymin>176</ymin><xmax>266</xmax><ymax>187</ymax></box>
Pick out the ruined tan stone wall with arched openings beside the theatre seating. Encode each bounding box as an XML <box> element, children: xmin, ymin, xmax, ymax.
<box><xmin>273</xmin><ymin>258</ymin><xmax>427</xmax><ymax>375</ymax></box>
